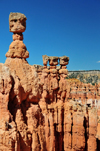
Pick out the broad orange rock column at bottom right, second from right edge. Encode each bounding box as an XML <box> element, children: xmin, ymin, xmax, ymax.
<box><xmin>72</xmin><ymin>105</ymin><xmax>85</xmax><ymax>151</ymax></box>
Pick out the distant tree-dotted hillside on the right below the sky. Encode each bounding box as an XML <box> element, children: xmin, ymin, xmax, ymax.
<box><xmin>67</xmin><ymin>70</ymin><xmax>100</xmax><ymax>85</ymax></box>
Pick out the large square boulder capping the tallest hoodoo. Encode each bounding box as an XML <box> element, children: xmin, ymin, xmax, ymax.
<box><xmin>9</xmin><ymin>13</ymin><xmax>27</xmax><ymax>33</ymax></box>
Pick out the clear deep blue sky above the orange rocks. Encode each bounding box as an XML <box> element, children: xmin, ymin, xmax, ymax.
<box><xmin>0</xmin><ymin>0</ymin><xmax>100</xmax><ymax>70</ymax></box>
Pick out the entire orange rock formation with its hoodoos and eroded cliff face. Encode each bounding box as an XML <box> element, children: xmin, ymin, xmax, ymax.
<box><xmin>0</xmin><ymin>13</ymin><xmax>100</xmax><ymax>151</ymax></box>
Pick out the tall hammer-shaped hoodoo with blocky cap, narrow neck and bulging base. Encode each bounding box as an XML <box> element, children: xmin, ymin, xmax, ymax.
<box><xmin>6</xmin><ymin>13</ymin><xmax>29</xmax><ymax>59</ymax></box>
